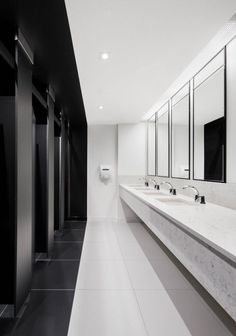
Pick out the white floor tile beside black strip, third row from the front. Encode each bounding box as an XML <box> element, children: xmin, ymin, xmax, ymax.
<box><xmin>82</xmin><ymin>241</ymin><xmax>122</xmax><ymax>260</ymax></box>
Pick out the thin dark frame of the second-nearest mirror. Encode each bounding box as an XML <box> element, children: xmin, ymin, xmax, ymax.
<box><xmin>170</xmin><ymin>81</ymin><xmax>191</xmax><ymax>180</ymax></box>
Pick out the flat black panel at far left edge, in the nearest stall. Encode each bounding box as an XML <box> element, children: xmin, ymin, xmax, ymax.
<box><xmin>0</xmin><ymin>97</ymin><xmax>15</xmax><ymax>304</ymax></box>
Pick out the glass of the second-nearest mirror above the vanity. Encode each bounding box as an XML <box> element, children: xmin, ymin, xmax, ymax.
<box><xmin>171</xmin><ymin>83</ymin><xmax>190</xmax><ymax>179</ymax></box>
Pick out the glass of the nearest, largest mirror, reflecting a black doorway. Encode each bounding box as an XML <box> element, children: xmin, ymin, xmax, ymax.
<box><xmin>193</xmin><ymin>52</ymin><xmax>226</xmax><ymax>182</ymax></box>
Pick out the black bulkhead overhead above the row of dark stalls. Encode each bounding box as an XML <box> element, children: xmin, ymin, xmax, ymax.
<box><xmin>0</xmin><ymin>0</ymin><xmax>86</xmax><ymax>125</ymax></box>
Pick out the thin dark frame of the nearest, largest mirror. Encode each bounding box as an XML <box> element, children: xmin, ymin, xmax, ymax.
<box><xmin>192</xmin><ymin>47</ymin><xmax>227</xmax><ymax>183</ymax></box>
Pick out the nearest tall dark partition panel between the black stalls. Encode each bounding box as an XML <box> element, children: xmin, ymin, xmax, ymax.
<box><xmin>15</xmin><ymin>47</ymin><xmax>33</xmax><ymax>312</ymax></box>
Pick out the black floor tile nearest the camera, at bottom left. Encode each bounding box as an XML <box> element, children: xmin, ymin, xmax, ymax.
<box><xmin>0</xmin><ymin>291</ymin><xmax>74</xmax><ymax>336</ymax></box>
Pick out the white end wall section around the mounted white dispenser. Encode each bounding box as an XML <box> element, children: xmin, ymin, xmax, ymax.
<box><xmin>88</xmin><ymin>125</ymin><xmax>117</xmax><ymax>220</ymax></box>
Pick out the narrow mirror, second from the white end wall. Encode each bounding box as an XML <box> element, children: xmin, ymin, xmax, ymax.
<box><xmin>156</xmin><ymin>103</ymin><xmax>169</xmax><ymax>177</ymax></box>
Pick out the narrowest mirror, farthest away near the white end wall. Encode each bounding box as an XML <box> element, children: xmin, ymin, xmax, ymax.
<box><xmin>147</xmin><ymin>114</ymin><xmax>156</xmax><ymax>175</ymax></box>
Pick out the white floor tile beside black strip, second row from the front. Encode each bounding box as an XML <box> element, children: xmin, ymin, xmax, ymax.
<box><xmin>76</xmin><ymin>260</ymin><xmax>131</xmax><ymax>290</ymax></box>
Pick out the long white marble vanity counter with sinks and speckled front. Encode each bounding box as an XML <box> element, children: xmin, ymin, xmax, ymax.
<box><xmin>119</xmin><ymin>184</ymin><xmax>236</xmax><ymax>321</ymax></box>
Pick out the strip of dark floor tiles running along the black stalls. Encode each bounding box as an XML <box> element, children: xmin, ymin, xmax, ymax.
<box><xmin>0</xmin><ymin>222</ymin><xmax>86</xmax><ymax>336</ymax></box>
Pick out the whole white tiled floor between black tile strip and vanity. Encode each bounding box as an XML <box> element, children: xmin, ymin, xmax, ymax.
<box><xmin>68</xmin><ymin>222</ymin><xmax>234</xmax><ymax>336</ymax></box>
